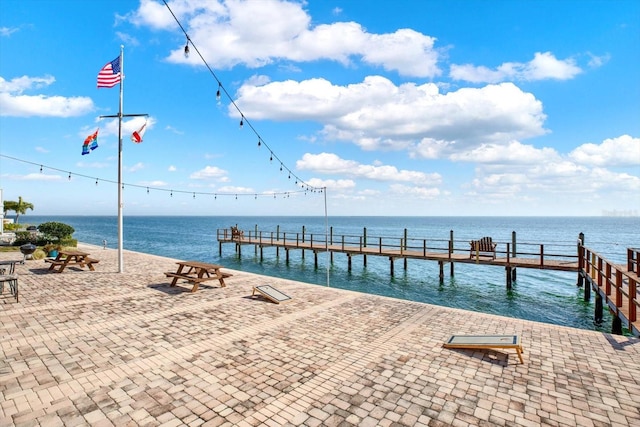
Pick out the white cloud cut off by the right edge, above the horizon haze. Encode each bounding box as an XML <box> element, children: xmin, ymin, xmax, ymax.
<box><xmin>569</xmin><ymin>135</ymin><xmax>640</xmax><ymax>167</ymax></box>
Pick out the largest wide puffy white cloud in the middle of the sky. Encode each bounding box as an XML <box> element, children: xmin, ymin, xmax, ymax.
<box><xmin>235</xmin><ymin>76</ymin><xmax>546</xmax><ymax>154</ymax></box>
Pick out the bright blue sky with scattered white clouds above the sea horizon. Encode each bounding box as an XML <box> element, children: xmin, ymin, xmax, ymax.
<box><xmin>0</xmin><ymin>0</ymin><xmax>640</xmax><ymax>216</ymax></box>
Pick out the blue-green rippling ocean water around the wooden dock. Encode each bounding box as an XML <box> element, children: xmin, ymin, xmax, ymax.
<box><xmin>21</xmin><ymin>215</ymin><xmax>640</xmax><ymax>332</ymax></box>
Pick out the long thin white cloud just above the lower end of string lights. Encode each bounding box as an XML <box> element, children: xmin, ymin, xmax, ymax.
<box><xmin>296</xmin><ymin>153</ymin><xmax>442</xmax><ymax>184</ymax></box>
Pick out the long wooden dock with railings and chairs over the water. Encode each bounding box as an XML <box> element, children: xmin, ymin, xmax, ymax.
<box><xmin>216</xmin><ymin>227</ymin><xmax>640</xmax><ymax>336</ymax></box>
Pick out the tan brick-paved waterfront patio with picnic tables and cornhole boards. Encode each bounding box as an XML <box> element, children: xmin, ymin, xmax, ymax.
<box><xmin>0</xmin><ymin>245</ymin><xmax>640</xmax><ymax>426</ymax></box>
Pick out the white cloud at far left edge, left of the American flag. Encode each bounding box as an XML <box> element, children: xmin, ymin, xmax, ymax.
<box><xmin>0</xmin><ymin>76</ymin><xmax>94</xmax><ymax>117</ymax></box>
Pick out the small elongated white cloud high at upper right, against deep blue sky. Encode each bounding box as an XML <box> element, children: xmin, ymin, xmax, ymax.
<box><xmin>449</xmin><ymin>52</ymin><xmax>582</xmax><ymax>83</ymax></box>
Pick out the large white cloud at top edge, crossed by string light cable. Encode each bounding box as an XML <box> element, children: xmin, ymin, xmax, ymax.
<box><xmin>129</xmin><ymin>0</ymin><xmax>441</xmax><ymax>77</ymax></box>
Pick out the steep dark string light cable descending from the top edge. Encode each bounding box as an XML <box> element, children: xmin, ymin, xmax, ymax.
<box><xmin>162</xmin><ymin>0</ymin><xmax>326</xmax><ymax>193</ymax></box>
